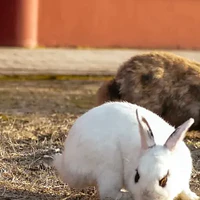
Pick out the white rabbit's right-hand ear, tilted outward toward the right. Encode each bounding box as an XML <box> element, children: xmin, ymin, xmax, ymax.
<box><xmin>164</xmin><ymin>118</ymin><xmax>194</xmax><ymax>151</ymax></box>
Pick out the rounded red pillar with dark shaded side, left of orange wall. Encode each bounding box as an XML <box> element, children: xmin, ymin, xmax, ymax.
<box><xmin>0</xmin><ymin>0</ymin><xmax>38</xmax><ymax>47</ymax></box>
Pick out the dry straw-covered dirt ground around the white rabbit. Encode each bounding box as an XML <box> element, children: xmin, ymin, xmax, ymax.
<box><xmin>0</xmin><ymin>80</ymin><xmax>200</xmax><ymax>200</ymax></box>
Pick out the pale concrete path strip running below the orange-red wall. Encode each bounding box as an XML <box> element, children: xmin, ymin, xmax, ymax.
<box><xmin>0</xmin><ymin>48</ymin><xmax>200</xmax><ymax>75</ymax></box>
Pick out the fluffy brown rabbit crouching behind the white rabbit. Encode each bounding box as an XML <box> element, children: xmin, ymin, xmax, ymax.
<box><xmin>97</xmin><ymin>52</ymin><xmax>200</xmax><ymax>130</ymax></box>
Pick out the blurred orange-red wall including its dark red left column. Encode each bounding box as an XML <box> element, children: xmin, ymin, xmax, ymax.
<box><xmin>0</xmin><ymin>0</ymin><xmax>200</xmax><ymax>49</ymax></box>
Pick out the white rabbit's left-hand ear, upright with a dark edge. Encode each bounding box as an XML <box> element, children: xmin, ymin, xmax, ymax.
<box><xmin>136</xmin><ymin>109</ymin><xmax>156</xmax><ymax>150</ymax></box>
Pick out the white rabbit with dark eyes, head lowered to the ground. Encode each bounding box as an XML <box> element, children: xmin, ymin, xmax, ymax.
<box><xmin>54</xmin><ymin>102</ymin><xmax>199</xmax><ymax>200</ymax></box>
